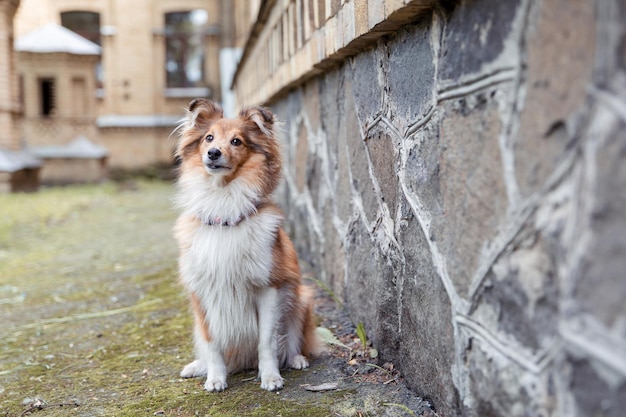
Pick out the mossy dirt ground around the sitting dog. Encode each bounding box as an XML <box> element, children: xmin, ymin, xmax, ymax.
<box><xmin>0</xmin><ymin>180</ymin><xmax>436</xmax><ymax>417</ymax></box>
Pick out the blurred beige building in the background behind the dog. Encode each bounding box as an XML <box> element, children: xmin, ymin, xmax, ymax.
<box><xmin>9</xmin><ymin>0</ymin><xmax>259</xmax><ymax>175</ymax></box>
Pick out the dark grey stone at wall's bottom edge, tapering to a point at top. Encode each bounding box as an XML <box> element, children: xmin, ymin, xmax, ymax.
<box><xmin>381</xmin><ymin>197</ymin><xmax>459</xmax><ymax>416</ymax></box>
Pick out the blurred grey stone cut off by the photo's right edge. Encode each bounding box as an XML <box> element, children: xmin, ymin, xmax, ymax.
<box><xmin>574</xmin><ymin>116</ymin><xmax>626</xmax><ymax>332</ymax></box>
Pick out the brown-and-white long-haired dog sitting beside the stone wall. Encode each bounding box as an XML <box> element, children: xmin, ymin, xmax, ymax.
<box><xmin>174</xmin><ymin>99</ymin><xmax>320</xmax><ymax>392</ymax></box>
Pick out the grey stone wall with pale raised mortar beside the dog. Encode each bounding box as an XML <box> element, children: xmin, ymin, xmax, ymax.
<box><xmin>266</xmin><ymin>0</ymin><xmax>626</xmax><ymax>417</ymax></box>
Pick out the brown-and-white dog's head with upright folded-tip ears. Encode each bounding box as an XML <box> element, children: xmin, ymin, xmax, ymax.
<box><xmin>176</xmin><ymin>99</ymin><xmax>281</xmax><ymax>194</ymax></box>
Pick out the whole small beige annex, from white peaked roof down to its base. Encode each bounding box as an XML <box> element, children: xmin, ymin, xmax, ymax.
<box><xmin>15</xmin><ymin>23</ymin><xmax>108</xmax><ymax>184</ymax></box>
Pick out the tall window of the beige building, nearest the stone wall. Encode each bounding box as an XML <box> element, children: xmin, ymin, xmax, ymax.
<box><xmin>165</xmin><ymin>9</ymin><xmax>209</xmax><ymax>88</ymax></box>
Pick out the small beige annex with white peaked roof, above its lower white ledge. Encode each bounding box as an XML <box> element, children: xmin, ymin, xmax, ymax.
<box><xmin>15</xmin><ymin>24</ymin><xmax>100</xmax><ymax>148</ymax></box>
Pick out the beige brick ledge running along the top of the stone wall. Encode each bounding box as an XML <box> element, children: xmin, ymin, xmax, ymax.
<box><xmin>232</xmin><ymin>0</ymin><xmax>440</xmax><ymax>104</ymax></box>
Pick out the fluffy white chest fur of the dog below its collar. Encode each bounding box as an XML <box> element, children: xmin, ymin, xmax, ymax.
<box><xmin>180</xmin><ymin>212</ymin><xmax>282</xmax><ymax>349</ymax></box>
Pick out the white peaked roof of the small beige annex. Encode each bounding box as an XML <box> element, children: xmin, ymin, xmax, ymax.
<box><xmin>14</xmin><ymin>23</ymin><xmax>102</xmax><ymax>55</ymax></box>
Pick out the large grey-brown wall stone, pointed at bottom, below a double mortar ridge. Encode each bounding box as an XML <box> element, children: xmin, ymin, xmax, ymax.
<box><xmin>426</xmin><ymin>87</ymin><xmax>508</xmax><ymax>296</ymax></box>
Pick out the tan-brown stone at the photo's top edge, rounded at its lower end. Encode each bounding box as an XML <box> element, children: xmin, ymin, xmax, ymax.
<box><xmin>515</xmin><ymin>0</ymin><xmax>596</xmax><ymax>196</ymax></box>
